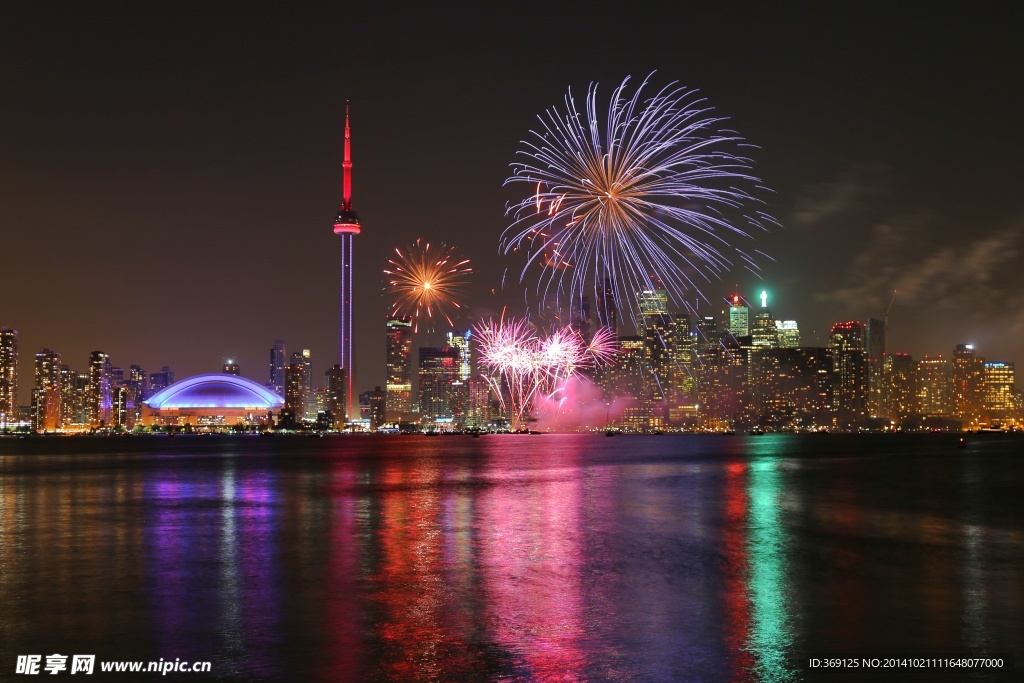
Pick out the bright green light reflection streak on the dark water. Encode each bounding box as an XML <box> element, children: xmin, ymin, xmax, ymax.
<box><xmin>748</xmin><ymin>448</ymin><xmax>798</xmax><ymax>681</ymax></box>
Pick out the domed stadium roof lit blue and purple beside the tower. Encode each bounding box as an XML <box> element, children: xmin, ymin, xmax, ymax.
<box><xmin>143</xmin><ymin>373</ymin><xmax>285</xmax><ymax>410</ymax></box>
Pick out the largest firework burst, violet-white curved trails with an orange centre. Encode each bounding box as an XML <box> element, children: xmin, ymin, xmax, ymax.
<box><xmin>502</xmin><ymin>78</ymin><xmax>775</xmax><ymax>327</ymax></box>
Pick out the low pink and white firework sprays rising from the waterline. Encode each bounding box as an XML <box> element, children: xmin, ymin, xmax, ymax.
<box><xmin>473</xmin><ymin>315</ymin><xmax>615</xmax><ymax>429</ymax></box>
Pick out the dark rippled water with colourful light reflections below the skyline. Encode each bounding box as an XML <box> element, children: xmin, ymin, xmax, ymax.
<box><xmin>0</xmin><ymin>434</ymin><xmax>1024</xmax><ymax>681</ymax></box>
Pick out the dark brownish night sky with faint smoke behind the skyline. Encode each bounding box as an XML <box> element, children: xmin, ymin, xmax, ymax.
<box><xmin>0</xmin><ymin>2</ymin><xmax>1024</xmax><ymax>402</ymax></box>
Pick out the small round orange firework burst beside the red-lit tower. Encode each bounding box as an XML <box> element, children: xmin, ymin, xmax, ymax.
<box><xmin>384</xmin><ymin>239</ymin><xmax>473</xmax><ymax>332</ymax></box>
